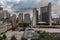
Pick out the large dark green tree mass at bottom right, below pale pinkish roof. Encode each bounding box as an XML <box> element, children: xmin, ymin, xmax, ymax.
<box><xmin>39</xmin><ymin>32</ymin><xmax>56</xmax><ymax>40</ymax></box>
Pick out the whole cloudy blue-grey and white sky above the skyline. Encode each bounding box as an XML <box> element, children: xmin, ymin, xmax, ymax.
<box><xmin>0</xmin><ymin>0</ymin><xmax>60</xmax><ymax>17</ymax></box>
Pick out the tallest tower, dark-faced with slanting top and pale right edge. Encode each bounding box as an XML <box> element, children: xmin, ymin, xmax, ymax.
<box><xmin>40</xmin><ymin>3</ymin><xmax>52</xmax><ymax>25</ymax></box>
